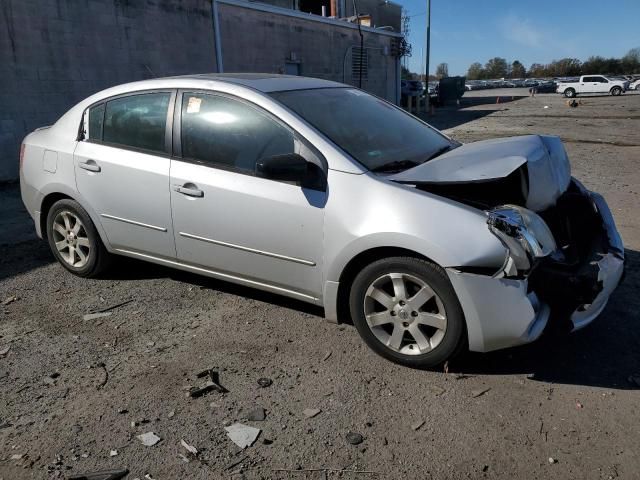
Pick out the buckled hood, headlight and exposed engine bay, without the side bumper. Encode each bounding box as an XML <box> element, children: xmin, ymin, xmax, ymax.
<box><xmin>391</xmin><ymin>135</ymin><xmax>624</xmax><ymax>329</ymax></box>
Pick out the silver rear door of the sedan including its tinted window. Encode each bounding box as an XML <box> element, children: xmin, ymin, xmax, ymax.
<box><xmin>74</xmin><ymin>91</ymin><xmax>175</xmax><ymax>259</ymax></box>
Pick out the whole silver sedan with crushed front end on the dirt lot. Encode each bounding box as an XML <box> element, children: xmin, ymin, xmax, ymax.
<box><xmin>20</xmin><ymin>74</ymin><xmax>624</xmax><ymax>367</ymax></box>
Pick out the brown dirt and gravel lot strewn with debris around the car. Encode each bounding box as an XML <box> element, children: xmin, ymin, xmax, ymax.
<box><xmin>0</xmin><ymin>89</ymin><xmax>640</xmax><ymax>480</ymax></box>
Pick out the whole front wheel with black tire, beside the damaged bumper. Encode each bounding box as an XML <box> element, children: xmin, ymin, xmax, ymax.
<box><xmin>349</xmin><ymin>257</ymin><xmax>467</xmax><ymax>368</ymax></box>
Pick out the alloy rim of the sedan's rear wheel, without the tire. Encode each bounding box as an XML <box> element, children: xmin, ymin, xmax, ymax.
<box><xmin>53</xmin><ymin>210</ymin><xmax>91</xmax><ymax>268</ymax></box>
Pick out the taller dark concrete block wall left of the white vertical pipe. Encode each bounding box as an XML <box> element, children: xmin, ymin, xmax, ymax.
<box><xmin>0</xmin><ymin>0</ymin><xmax>216</xmax><ymax>181</ymax></box>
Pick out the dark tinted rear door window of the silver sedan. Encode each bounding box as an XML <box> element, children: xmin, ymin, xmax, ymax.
<box><xmin>101</xmin><ymin>92</ymin><xmax>171</xmax><ymax>152</ymax></box>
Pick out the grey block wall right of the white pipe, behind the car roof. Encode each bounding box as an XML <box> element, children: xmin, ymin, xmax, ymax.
<box><xmin>218</xmin><ymin>2</ymin><xmax>398</xmax><ymax>102</ymax></box>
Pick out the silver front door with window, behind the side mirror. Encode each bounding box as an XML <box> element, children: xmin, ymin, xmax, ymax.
<box><xmin>171</xmin><ymin>92</ymin><xmax>326</xmax><ymax>300</ymax></box>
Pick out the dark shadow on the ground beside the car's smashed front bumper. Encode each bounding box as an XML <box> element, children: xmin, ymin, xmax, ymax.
<box><xmin>449</xmin><ymin>250</ymin><xmax>640</xmax><ymax>390</ymax></box>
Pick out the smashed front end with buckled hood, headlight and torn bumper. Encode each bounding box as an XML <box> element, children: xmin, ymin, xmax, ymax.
<box><xmin>396</xmin><ymin>136</ymin><xmax>624</xmax><ymax>351</ymax></box>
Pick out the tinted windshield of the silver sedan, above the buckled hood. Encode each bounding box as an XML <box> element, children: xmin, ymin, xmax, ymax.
<box><xmin>271</xmin><ymin>88</ymin><xmax>457</xmax><ymax>171</ymax></box>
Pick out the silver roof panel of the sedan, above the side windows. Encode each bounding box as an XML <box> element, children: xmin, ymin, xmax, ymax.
<box><xmin>136</xmin><ymin>73</ymin><xmax>346</xmax><ymax>93</ymax></box>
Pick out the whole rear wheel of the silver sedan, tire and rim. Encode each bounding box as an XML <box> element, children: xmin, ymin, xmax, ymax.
<box><xmin>47</xmin><ymin>199</ymin><xmax>112</xmax><ymax>277</ymax></box>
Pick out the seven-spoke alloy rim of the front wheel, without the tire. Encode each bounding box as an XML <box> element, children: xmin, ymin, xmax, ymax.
<box><xmin>364</xmin><ymin>273</ymin><xmax>447</xmax><ymax>355</ymax></box>
